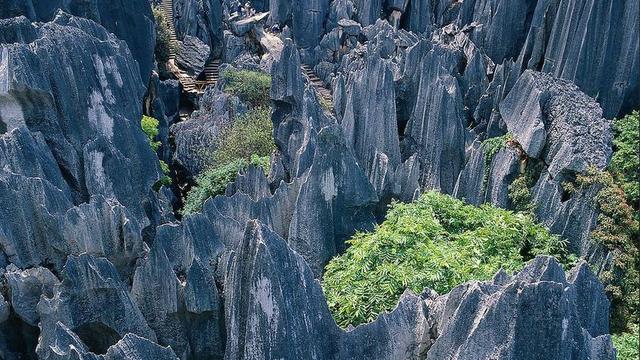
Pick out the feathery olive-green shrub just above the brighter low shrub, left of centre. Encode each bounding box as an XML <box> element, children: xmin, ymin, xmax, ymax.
<box><xmin>208</xmin><ymin>107</ymin><xmax>275</xmax><ymax>168</ymax></box>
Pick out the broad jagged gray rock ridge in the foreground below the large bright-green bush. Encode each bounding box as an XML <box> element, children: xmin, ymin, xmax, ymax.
<box><xmin>427</xmin><ymin>257</ymin><xmax>615</xmax><ymax>359</ymax></box>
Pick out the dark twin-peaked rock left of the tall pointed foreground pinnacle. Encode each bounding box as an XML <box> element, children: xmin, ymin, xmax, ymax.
<box><xmin>131</xmin><ymin>242</ymin><xmax>223</xmax><ymax>359</ymax></box>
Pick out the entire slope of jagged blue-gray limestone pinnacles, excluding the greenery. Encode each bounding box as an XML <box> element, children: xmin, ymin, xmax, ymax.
<box><xmin>0</xmin><ymin>0</ymin><xmax>640</xmax><ymax>359</ymax></box>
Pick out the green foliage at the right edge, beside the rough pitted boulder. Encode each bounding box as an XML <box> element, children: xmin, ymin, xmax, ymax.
<box><xmin>609</xmin><ymin>111</ymin><xmax>640</xmax><ymax>210</ymax></box>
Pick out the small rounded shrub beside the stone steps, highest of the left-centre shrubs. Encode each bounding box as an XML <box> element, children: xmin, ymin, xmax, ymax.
<box><xmin>222</xmin><ymin>70</ymin><xmax>271</xmax><ymax>107</ymax></box>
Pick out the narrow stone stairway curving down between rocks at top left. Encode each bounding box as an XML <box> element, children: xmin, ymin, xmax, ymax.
<box><xmin>160</xmin><ymin>0</ymin><xmax>220</xmax><ymax>95</ymax></box>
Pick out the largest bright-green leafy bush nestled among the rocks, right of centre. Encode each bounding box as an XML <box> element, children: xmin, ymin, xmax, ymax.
<box><xmin>323</xmin><ymin>192</ymin><xmax>570</xmax><ymax>326</ymax></box>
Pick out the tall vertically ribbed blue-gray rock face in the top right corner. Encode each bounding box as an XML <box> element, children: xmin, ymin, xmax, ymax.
<box><xmin>518</xmin><ymin>0</ymin><xmax>640</xmax><ymax>119</ymax></box>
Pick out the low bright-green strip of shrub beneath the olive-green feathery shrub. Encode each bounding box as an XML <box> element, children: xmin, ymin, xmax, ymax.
<box><xmin>182</xmin><ymin>155</ymin><xmax>269</xmax><ymax>215</ymax></box>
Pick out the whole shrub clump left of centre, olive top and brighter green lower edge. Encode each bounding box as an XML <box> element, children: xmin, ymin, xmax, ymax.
<box><xmin>182</xmin><ymin>107</ymin><xmax>275</xmax><ymax>215</ymax></box>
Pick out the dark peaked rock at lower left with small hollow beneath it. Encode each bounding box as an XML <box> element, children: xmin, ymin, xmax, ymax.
<box><xmin>37</xmin><ymin>255</ymin><xmax>156</xmax><ymax>359</ymax></box>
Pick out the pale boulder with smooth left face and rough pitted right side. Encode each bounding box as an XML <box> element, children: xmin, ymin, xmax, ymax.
<box><xmin>500</xmin><ymin>71</ymin><xmax>612</xmax><ymax>180</ymax></box>
